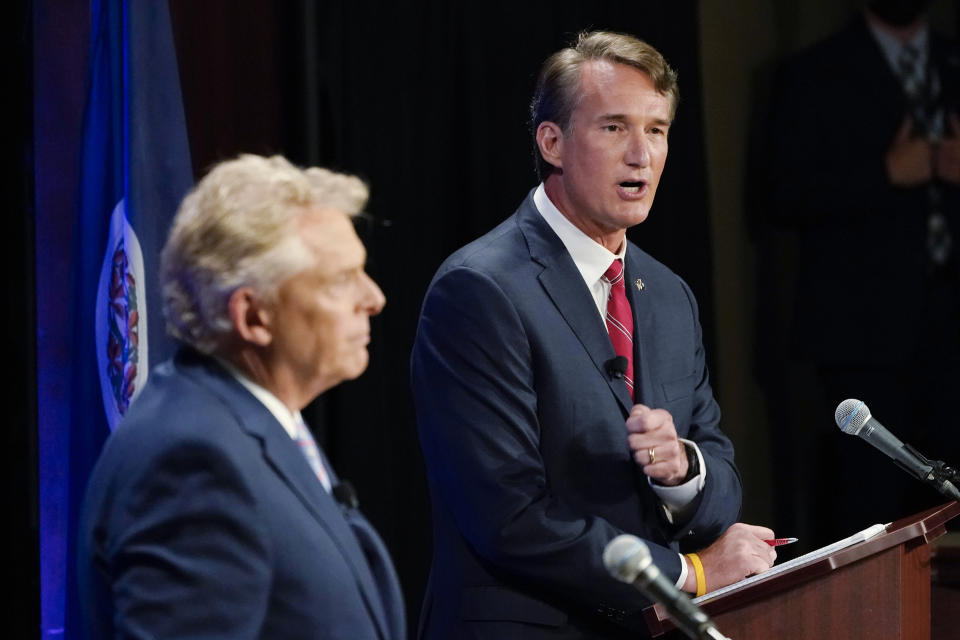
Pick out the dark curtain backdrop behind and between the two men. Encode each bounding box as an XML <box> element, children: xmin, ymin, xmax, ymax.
<box><xmin>171</xmin><ymin>0</ymin><xmax>713</xmax><ymax>628</ymax></box>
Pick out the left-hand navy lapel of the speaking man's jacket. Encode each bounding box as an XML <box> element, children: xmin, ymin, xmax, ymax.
<box><xmin>516</xmin><ymin>191</ymin><xmax>633</xmax><ymax>414</ymax></box>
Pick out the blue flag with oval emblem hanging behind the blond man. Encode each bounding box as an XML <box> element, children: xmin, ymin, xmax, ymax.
<box><xmin>40</xmin><ymin>0</ymin><xmax>193</xmax><ymax>637</ymax></box>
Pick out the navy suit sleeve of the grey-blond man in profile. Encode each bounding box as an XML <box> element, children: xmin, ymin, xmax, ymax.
<box><xmin>97</xmin><ymin>438</ymin><xmax>271</xmax><ymax>639</ymax></box>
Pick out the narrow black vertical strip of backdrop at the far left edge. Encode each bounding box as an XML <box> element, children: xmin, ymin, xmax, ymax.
<box><xmin>13</xmin><ymin>2</ymin><xmax>40</xmax><ymax>638</ymax></box>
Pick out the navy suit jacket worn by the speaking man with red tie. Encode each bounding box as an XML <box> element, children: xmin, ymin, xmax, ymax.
<box><xmin>412</xmin><ymin>194</ymin><xmax>740</xmax><ymax>640</ymax></box>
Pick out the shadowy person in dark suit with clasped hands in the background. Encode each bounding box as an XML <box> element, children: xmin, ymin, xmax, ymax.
<box><xmin>754</xmin><ymin>0</ymin><xmax>960</xmax><ymax>544</ymax></box>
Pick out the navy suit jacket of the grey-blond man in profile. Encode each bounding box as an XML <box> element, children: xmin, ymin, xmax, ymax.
<box><xmin>79</xmin><ymin>349</ymin><xmax>405</xmax><ymax>640</ymax></box>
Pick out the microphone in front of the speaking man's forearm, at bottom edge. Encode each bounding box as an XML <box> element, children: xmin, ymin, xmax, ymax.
<box><xmin>603</xmin><ymin>534</ymin><xmax>729</xmax><ymax>640</ymax></box>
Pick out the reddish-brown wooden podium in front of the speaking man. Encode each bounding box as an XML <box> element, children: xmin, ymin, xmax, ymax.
<box><xmin>643</xmin><ymin>502</ymin><xmax>960</xmax><ymax>640</ymax></box>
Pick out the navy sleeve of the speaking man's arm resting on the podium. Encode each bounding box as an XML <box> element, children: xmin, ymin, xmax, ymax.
<box><xmin>412</xmin><ymin>267</ymin><xmax>679</xmax><ymax>614</ymax></box>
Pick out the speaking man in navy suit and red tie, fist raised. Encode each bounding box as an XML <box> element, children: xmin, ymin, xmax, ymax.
<box><xmin>412</xmin><ymin>32</ymin><xmax>775</xmax><ymax>640</ymax></box>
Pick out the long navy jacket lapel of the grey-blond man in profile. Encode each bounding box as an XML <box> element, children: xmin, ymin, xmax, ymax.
<box><xmin>178</xmin><ymin>350</ymin><xmax>391</xmax><ymax>639</ymax></box>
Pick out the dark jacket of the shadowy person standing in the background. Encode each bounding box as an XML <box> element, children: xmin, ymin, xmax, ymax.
<box><xmin>768</xmin><ymin>17</ymin><xmax>960</xmax><ymax>365</ymax></box>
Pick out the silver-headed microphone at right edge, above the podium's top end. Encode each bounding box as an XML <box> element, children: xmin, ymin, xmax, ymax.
<box><xmin>834</xmin><ymin>400</ymin><xmax>960</xmax><ymax>500</ymax></box>
